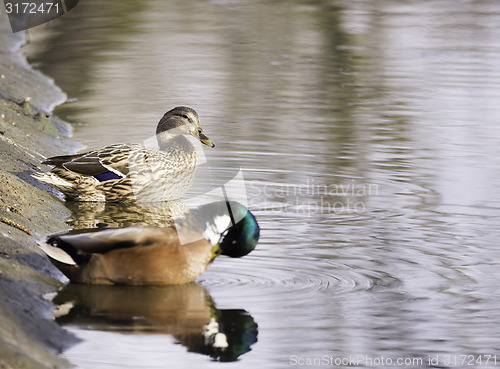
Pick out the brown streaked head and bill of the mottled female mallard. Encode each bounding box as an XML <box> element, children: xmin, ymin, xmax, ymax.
<box><xmin>156</xmin><ymin>106</ymin><xmax>215</xmax><ymax>147</ymax></box>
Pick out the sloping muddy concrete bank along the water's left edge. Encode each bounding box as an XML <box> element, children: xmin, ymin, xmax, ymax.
<box><xmin>0</xmin><ymin>10</ymin><xmax>82</xmax><ymax>369</ymax></box>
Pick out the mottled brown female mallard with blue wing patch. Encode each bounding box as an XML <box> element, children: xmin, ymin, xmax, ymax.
<box><xmin>35</xmin><ymin>106</ymin><xmax>215</xmax><ymax>202</ymax></box>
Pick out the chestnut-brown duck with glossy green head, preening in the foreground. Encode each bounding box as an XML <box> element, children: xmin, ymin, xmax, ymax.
<box><xmin>40</xmin><ymin>201</ymin><xmax>260</xmax><ymax>285</ymax></box>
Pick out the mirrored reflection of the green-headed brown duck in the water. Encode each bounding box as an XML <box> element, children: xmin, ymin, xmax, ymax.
<box><xmin>53</xmin><ymin>283</ymin><xmax>258</xmax><ymax>361</ymax></box>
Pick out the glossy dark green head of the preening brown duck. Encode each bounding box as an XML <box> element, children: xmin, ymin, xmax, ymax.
<box><xmin>209</xmin><ymin>201</ymin><xmax>260</xmax><ymax>258</ymax></box>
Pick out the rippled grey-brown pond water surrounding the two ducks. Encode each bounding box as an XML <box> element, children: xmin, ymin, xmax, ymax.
<box><xmin>26</xmin><ymin>0</ymin><xmax>500</xmax><ymax>368</ymax></box>
